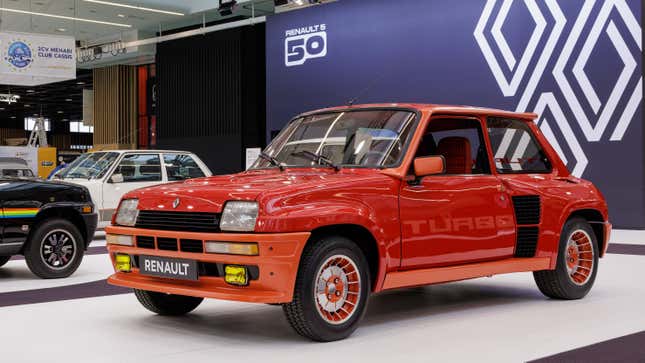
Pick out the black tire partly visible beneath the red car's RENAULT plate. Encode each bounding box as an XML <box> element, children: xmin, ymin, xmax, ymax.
<box><xmin>134</xmin><ymin>289</ymin><xmax>204</xmax><ymax>316</ymax></box>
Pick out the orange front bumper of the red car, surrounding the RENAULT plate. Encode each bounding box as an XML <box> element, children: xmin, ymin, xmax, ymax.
<box><xmin>105</xmin><ymin>226</ymin><xmax>310</xmax><ymax>303</ymax></box>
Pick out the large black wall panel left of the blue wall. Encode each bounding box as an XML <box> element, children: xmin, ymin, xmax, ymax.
<box><xmin>156</xmin><ymin>24</ymin><xmax>265</xmax><ymax>174</ymax></box>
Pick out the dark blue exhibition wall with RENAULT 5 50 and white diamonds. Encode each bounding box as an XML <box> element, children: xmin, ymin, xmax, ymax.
<box><xmin>266</xmin><ymin>0</ymin><xmax>645</xmax><ymax>228</ymax></box>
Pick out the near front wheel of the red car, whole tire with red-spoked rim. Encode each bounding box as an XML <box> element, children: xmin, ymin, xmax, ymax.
<box><xmin>282</xmin><ymin>237</ymin><xmax>370</xmax><ymax>342</ymax></box>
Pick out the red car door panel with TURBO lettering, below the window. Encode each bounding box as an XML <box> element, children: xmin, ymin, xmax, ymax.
<box><xmin>400</xmin><ymin>175</ymin><xmax>515</xmax><ymax>268</ymax></box>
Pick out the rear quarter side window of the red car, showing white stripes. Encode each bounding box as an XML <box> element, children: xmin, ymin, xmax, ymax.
<box><xmin>487</xmin><ymin>118</ymin><xmax>551</xmax><ymax>174</ymax></box>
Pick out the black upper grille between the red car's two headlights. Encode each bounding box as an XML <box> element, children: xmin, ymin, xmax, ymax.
<box><xmin>135</xmin><ymin>210</ymin><xmax>220</xmax><ymax>233</ymax></box>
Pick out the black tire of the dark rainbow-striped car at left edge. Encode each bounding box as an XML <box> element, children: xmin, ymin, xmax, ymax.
<box><xmin>24</xmin><ymin>218</ymin><xmax>85</xmax><ymax>279</ymax></box>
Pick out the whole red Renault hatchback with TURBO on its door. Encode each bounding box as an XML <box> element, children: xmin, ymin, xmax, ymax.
<box><xmin>106</xmin><ymin>104</ymin><xmax>611</xmax><ymax>341</ymax></box>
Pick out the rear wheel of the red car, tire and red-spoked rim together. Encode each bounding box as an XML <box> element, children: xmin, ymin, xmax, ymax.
<box><xmin>533</xmin><ymin>218</ymin><xmax>599</xmax><ymax>300</ymax></box>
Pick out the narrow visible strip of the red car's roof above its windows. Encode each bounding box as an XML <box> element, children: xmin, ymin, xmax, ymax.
<box><xmin>300</xmin><ymin>103</ymin><xmax>538</xmax><ymax>121</ymax></box>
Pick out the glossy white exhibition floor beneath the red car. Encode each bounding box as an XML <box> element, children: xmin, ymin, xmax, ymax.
<box><xmin>0</xmin><ymin>234</ymin><xmax>645</xmax><ymax>363</ymax></box>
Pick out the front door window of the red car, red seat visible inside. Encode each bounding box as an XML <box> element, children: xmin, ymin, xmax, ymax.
<box><xmin>415</xmin><ymin>118</ymin><xmax>490</xmax><ymax>174</ymax></box>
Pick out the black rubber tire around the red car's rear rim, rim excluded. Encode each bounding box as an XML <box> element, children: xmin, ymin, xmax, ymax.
<box><xmin>533</xmin><ymin>218</ymin><xmax>600</xmax><ymax>300</ymax></box>
